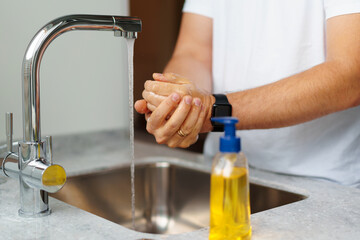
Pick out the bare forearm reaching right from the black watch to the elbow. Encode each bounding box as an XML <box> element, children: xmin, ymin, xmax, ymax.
<box><xmin>227</xmin><ymin>61</ymin><xmax>360</xmax><ymax>129</ymax></box>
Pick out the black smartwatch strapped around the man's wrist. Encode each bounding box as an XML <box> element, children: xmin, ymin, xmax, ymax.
<box><xmin>211</xmin><ymin>94</ymin><xmax>232</xmax><ymax>132</ymax></box>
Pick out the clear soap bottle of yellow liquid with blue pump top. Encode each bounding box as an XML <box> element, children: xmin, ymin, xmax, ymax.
<box><xmin>209</xmin><ymin>117</ymin><xmax>251</xmax><ymax>240</ymax></box>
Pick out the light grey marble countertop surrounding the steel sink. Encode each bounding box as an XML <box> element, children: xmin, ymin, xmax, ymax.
<box><xmin>0</xmin><ymin>131</ymin><xmax>360</xmax><ymax>240</ymax></box>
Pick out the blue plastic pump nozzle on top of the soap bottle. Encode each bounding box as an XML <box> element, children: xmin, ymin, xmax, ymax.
<box><xmin>211</xmin><ymin>117</ymin><xmax>241</xmax><ymax>153</ymax></box>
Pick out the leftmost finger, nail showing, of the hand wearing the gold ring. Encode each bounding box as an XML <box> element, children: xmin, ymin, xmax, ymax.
<box><xmin>146</xmin><ymin>93</ymin><xmax>180</xmax><ymax>131</ymax></box>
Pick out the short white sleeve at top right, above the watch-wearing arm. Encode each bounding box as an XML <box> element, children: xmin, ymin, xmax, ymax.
<box><xmin>324</xmin><ymin>0</ymin><xmax>360</xmax><ymax>19</ymax></box>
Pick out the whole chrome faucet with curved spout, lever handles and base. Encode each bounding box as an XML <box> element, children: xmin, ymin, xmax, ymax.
<box><xmin>0</xmin><ymin>15</ymin><xmax>141</xmax><ymax>217</ymax></box>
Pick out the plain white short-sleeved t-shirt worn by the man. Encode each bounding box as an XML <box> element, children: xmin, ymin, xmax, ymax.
<box><xmin>183</xmin><ymin>0</ymin><xmax>360</xmax><ymax>186</ymax></box>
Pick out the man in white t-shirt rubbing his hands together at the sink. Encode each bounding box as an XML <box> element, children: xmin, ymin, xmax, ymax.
<box><xmin>135</xmin><ymin>0</ymin><xmax>360</xmax><ymax>187</ymax></box>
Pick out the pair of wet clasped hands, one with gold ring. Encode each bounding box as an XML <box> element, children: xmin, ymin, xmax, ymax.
<box><xmin>135</xmin><ymin>73</ymin><xmax>210</xmax><ymax>148</ymax></box>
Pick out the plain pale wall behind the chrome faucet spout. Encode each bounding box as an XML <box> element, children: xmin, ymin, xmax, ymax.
<box><xmin>0</xmin><ymin>0</ymin><xmax>129</xmax><ymax>141</ymax></box>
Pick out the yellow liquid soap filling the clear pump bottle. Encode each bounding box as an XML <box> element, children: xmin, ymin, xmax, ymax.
<box><xmin>209</xmin><ymin>167</ymin><xmax>251</xmax><ymax>240</ymax></box>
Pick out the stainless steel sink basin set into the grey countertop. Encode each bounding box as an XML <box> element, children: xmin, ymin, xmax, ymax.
<box><xmin>51</xmin><ymin>162</ymin><xmax>305</xmax><ymax>234</ymax></box>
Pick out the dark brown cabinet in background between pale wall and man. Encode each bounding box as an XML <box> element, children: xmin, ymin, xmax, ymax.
<box><xmin>129</xmin><ymin>0</ymin><xmax>204</xmax><ymax>152</ymax></box>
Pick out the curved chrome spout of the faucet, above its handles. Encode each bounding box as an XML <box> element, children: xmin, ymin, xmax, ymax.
<box><xmin>22</xmin><ymin>15</ymin><xmax>141</xmax><ymax>142</ymax></box>
